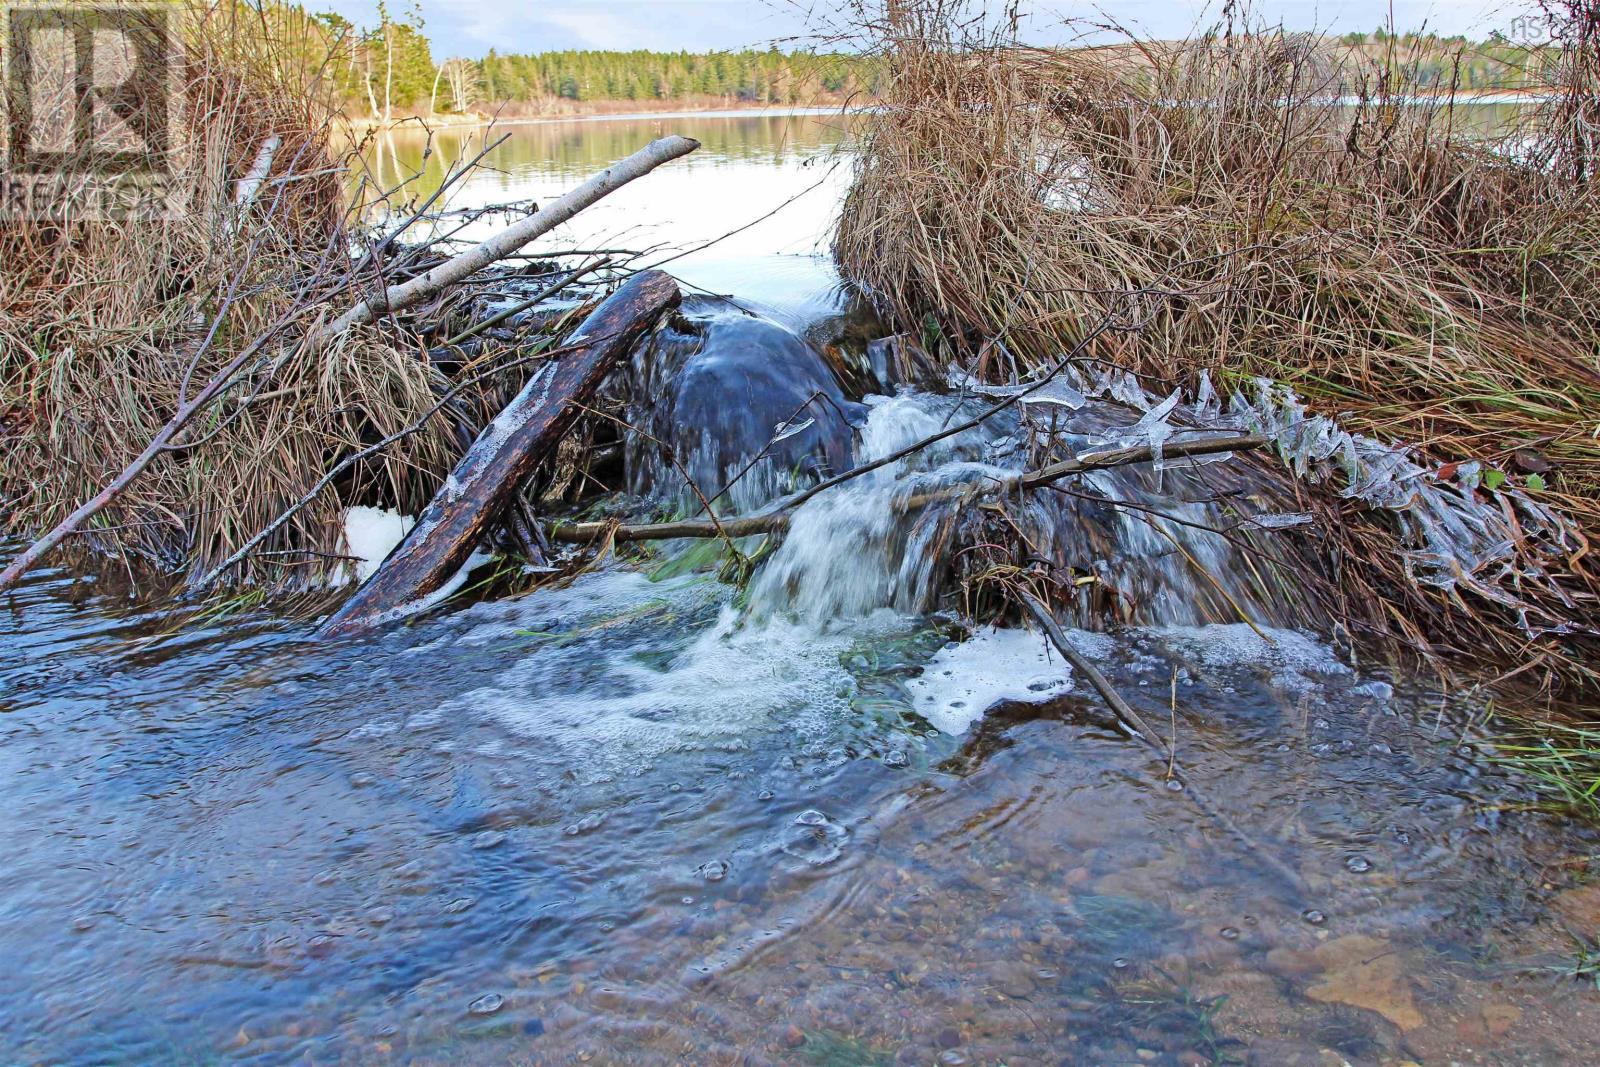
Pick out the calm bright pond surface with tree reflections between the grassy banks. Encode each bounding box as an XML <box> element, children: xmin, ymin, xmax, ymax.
<box><xmin>356</xmin><ymin>115</ymin><xmax>850</xmax><ymax>323</ymax></box>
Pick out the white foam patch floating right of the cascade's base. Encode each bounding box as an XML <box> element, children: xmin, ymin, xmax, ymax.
<box><xmin>906</xmin><ymin>627</ymin><xmax>1072</xmax><ymax>734</ymax></box>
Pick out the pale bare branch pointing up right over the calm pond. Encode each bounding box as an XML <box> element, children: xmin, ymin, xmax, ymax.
<box><xmin>310</xmin><ymin>134</ymin><xmax>699</xmax><ymax>347</ymax></box>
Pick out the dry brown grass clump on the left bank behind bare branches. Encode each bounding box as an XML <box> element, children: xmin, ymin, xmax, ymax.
<box><xmin>0</xmin><ymin>5</ymin><xmax>499</xmax><ymax>582</ymax></box>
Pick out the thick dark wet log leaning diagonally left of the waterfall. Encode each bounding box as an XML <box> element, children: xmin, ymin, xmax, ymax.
<box><xmin>320</xmin><ymin>270</ymin><xmax>682</xmax><ymax>637</ymax></box>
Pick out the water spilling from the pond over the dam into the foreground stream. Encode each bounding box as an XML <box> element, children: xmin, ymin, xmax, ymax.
<box><xmin>0</xmin><ymin>108</ymin><xmax>1600</xmax><ymax>1067</ymax></box>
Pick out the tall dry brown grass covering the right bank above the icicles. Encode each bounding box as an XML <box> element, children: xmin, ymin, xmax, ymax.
<box><xmin>835</xmin><ymin>0</ymin><xmax>1600</xmax><ymax>697</ymax></box>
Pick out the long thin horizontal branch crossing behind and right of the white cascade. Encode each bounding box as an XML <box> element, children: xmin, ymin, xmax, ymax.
<box><xmin>550</xmin><ymin>435</ymin><xmax>1267</xmax><ymax>544</ymax></box>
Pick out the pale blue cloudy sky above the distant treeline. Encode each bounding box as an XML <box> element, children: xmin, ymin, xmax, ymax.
<box><xmin>306</xmin><ymin>0</ymin><xmax>1531</xmax><ymax>59</ymax></box>
